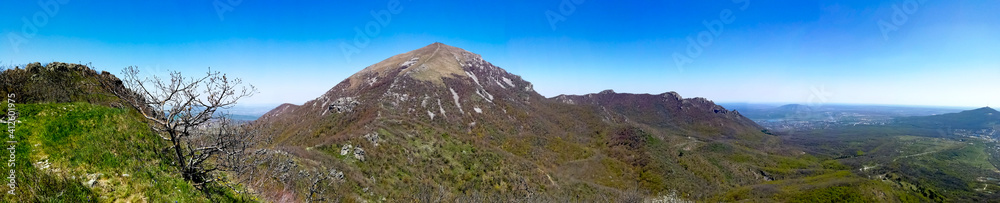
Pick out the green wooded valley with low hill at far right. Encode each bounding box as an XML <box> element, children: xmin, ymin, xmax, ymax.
<box><xmin>768</xmin><ymin>108</ymin><xmax>1000</xmax><ymax>202</ymax></box>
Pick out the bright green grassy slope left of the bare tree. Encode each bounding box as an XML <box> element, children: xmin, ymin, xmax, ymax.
<box><xmin>2</xmin><ymin>103</ymin><xmax>251</xmax><ymax>202</ymax></box>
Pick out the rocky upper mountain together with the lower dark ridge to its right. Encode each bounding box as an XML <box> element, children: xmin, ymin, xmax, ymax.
<box><xmin>261</xmin><ymin>42</ymin><xmax>762</xmax><ymax>144</ymax></box>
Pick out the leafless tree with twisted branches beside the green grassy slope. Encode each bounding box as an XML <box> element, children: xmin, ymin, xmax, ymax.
<box><xmin>105</xmin><ymin>66</ymin><xmax>266</xmax><ymax>188</ymax></box>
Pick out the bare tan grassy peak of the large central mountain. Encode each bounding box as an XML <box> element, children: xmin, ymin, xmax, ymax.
<box><xmin>351</xmin><ymin>42</ymin><xmax>482</xmax><ymax>87</ymax></box>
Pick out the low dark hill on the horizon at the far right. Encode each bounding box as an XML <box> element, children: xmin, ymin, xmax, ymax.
<box><xmin>896</xmin><ymin>107</ymin><xmax>1000</xmax><ymax>129</ymax></box>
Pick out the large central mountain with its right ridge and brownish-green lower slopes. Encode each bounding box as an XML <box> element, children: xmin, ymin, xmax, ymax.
<box><xmin>257</xmin><ymin>43</ymin><xmax>916</xmax><ymax>201</ymax></box>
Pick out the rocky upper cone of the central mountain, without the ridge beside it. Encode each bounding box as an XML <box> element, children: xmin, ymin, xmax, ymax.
<box><xmin>262</xmin><ymin>43</ymin><xmax>546</xmax><ymax>144</ymax></box>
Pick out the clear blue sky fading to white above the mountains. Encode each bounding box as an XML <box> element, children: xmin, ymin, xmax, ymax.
<box><xmin>0</xmin><ymin>0</ymin><xmax>1000</xmax><ymax>107</ymax></box>
